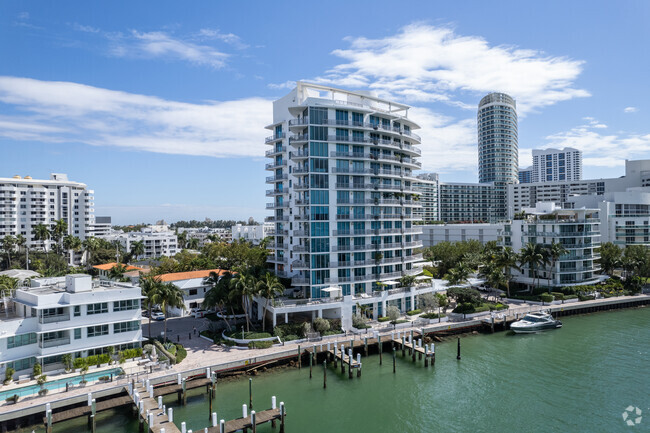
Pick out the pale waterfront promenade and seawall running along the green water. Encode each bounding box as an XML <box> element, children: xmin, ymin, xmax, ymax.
<box><xmin>0</xmin><ymin>294</ymin><xmax>650</xmax><ymax>432</ymax></box>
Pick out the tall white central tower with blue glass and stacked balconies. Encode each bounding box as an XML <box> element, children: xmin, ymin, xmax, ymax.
<box><xmin>266</xmin><ymin>82</ymin><xmax>422</xmax><ymax>300</ymax></box>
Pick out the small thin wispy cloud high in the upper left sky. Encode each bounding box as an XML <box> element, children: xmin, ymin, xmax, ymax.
<box><xmin>111</xmin><ymin>30</ymin><xmax>229</xmax><ymax>69</ymax></box>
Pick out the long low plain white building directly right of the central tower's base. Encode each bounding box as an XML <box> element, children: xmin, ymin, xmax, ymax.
<box><xmin>420</xmin><ymin>223</ymin><xmax>504</xmax><ymax>248</ymax></box>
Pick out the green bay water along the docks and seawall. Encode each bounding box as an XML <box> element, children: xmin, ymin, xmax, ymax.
<box><xmin>27</xmin><ymin>308</ymin><xmax>650</xmax><ymax>433</ymax></box>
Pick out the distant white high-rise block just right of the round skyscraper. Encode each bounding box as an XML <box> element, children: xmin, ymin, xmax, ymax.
<box><xmin>531</xmin><ymin>147</ymin><xmax>582</xmax><ymax>182</ymax></box>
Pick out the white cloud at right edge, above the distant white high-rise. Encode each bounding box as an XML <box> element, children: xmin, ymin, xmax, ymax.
<box><xmin>546</xmin><ymin>118</ymin><xmax>650</xmax><ymax>167</ymax></box>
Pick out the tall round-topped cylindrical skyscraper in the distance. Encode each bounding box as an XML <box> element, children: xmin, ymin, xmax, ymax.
<box><xmin>477</xmin><ymin>93</ymin><xmax>519</xmax><ymax>186</ymax></box>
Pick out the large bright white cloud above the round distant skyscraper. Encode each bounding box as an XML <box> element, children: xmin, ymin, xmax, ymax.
<box><xmin>317</xmin><ymin>24</ymin><xmax>590</xmax><ymax>115</ymax></box>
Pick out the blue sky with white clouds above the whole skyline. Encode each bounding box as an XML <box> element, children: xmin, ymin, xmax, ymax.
<box><xmin>0</xmin><ymin>0</ymin><xmax>650</xmax><ymax>224</ymax></box>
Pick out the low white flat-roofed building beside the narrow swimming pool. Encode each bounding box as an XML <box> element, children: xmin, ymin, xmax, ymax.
<box><xmin>0</xmin><ymin>274</ymin><xmax>142</xmax><ymax>377</ymax></box>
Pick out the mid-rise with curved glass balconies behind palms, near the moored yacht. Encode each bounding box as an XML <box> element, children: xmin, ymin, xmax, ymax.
<box><xmin>503</xmin><ymin>203</ymin><xmax>603</xmax><ymax>287</ymax></box>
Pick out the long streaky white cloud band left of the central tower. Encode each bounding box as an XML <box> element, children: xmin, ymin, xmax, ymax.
<box><xmin>0</xmin><ymin>77</ymin><xmax>272</xmax><ymax>157</ymax></box>
